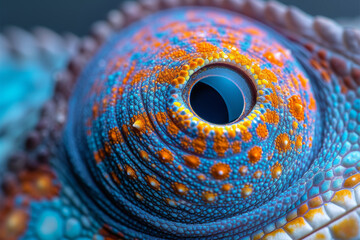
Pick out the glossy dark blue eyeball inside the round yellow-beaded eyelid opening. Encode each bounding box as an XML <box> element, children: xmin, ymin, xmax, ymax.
<box><xmin>184</xmin><ymin>64</ymin><xmax>256</xmax><ymax>124</ymax></box>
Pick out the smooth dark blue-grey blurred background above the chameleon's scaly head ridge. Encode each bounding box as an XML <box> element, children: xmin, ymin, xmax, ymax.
<box><xmin>0</xmin><ymin>0</ymin><xmax>360</xmax><ymax>35</ymax></box>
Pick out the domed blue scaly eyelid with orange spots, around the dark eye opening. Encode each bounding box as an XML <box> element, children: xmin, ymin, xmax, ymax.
<box><xmin>64</xmin><ymin>8</ymin><xmax>319</xmax><ymax>237</ymax></box>
